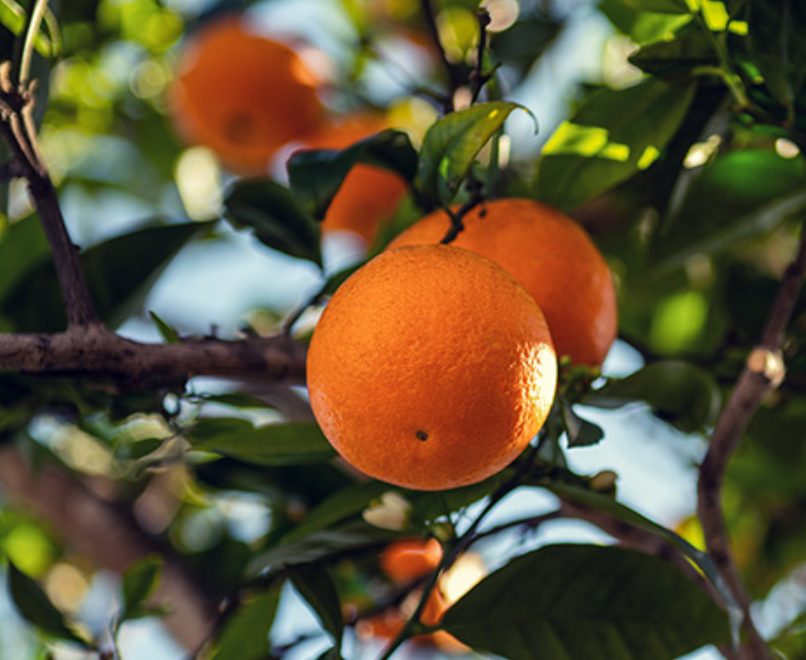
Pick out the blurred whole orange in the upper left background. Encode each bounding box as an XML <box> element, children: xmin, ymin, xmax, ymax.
<box><xmin>169</xmin><ymin>16</ymin><xmax>324</xmax><ymax>174</ymax></box>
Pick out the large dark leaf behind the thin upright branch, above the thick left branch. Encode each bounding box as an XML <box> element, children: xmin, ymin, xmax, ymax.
<box><xmin>0</xmin><ymin>222</ymin><xmax>210</xmax><ymax>332</ymax></box>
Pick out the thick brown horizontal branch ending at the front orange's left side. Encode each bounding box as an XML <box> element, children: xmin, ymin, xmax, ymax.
<box><xmin>0</xmin><ymin>326</ymin><xmax>306</xmax><ymax>389</ymax></box>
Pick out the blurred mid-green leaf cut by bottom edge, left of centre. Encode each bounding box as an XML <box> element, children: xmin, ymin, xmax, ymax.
<box><xmin>210</xmin><ymin>585</ymin><xmax>280</xmax><ymax>660</ymax></box>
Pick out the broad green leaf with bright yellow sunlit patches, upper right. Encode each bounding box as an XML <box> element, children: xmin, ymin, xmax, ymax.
<box><xmin>535</xmin><ymin>78</ymin><xmax>696</xmax><ymax>209</ymax></box>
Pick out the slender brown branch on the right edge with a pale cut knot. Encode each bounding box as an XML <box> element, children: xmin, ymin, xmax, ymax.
<box><xmin>697</xmin><ymin>222</ymin><xmax>806</xmax><ymax>659</ymax></box>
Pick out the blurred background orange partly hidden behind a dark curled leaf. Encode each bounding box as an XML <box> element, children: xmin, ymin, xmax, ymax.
<box><xmin>304</xmin><ymin>114</ymin><xmax>406</xmax><ymax>245</ymax></box>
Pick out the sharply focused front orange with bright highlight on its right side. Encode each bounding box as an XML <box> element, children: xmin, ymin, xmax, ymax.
<box><xmin>307</xmin><ymin>245</ymin><xmax>557</xmax><ymax>490</ymax></box>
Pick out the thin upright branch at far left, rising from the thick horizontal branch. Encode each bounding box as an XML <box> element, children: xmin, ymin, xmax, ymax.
<box><xmin>0</xmin><ymin>62</ymin><xmax>100</xmax><ymax>327</ymax></box>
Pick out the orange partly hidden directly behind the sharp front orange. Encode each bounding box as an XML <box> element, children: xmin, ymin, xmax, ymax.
<box><xmin>389</xmin><ymin>199</ymin><xmax>618</xmax><ymax>367</ymax></box>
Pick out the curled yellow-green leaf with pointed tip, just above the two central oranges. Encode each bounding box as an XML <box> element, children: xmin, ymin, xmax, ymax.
<box><xmin>414</xmin><ymin>101</ymin><xmax>528</xmax><ymax>204</ymax></box>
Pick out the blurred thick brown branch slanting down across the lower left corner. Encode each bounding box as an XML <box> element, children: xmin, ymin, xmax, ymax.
<box><xmin>0</xmin><ymin>449</ymin><xmax>217</xmax><ymax>650</ymax></box>
